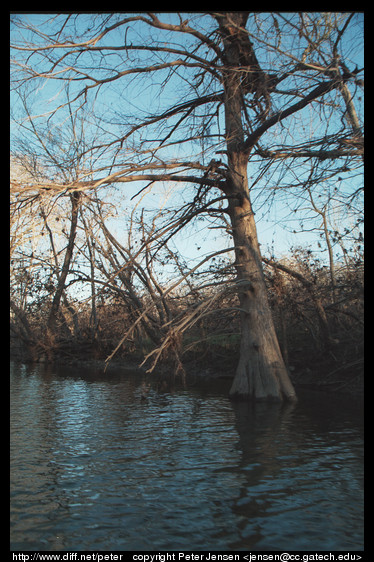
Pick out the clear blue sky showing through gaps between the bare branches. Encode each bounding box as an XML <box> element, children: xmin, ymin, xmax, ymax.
<box><xmin>11</xmin><ymin>13</ymin><xmax>363</xmax><ymax>272</ymax></box>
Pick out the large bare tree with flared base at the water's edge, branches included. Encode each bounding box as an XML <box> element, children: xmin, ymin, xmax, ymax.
<box><xmin>13</xmin><ymin>12</ymin><xmax>363</xmax><ymax>400</ymax></box>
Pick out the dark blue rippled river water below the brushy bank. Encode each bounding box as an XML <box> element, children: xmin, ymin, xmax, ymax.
<box><xmin>10</xmin><ymin>363</ymin><xmax>363</xmax><ymax>552</ymax></box>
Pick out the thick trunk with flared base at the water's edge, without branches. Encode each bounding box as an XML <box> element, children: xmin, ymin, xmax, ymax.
<box><xmin>217</xmin><ymin>12</ymin><xmax>296</xmax><ymax>400</ymax></box>
